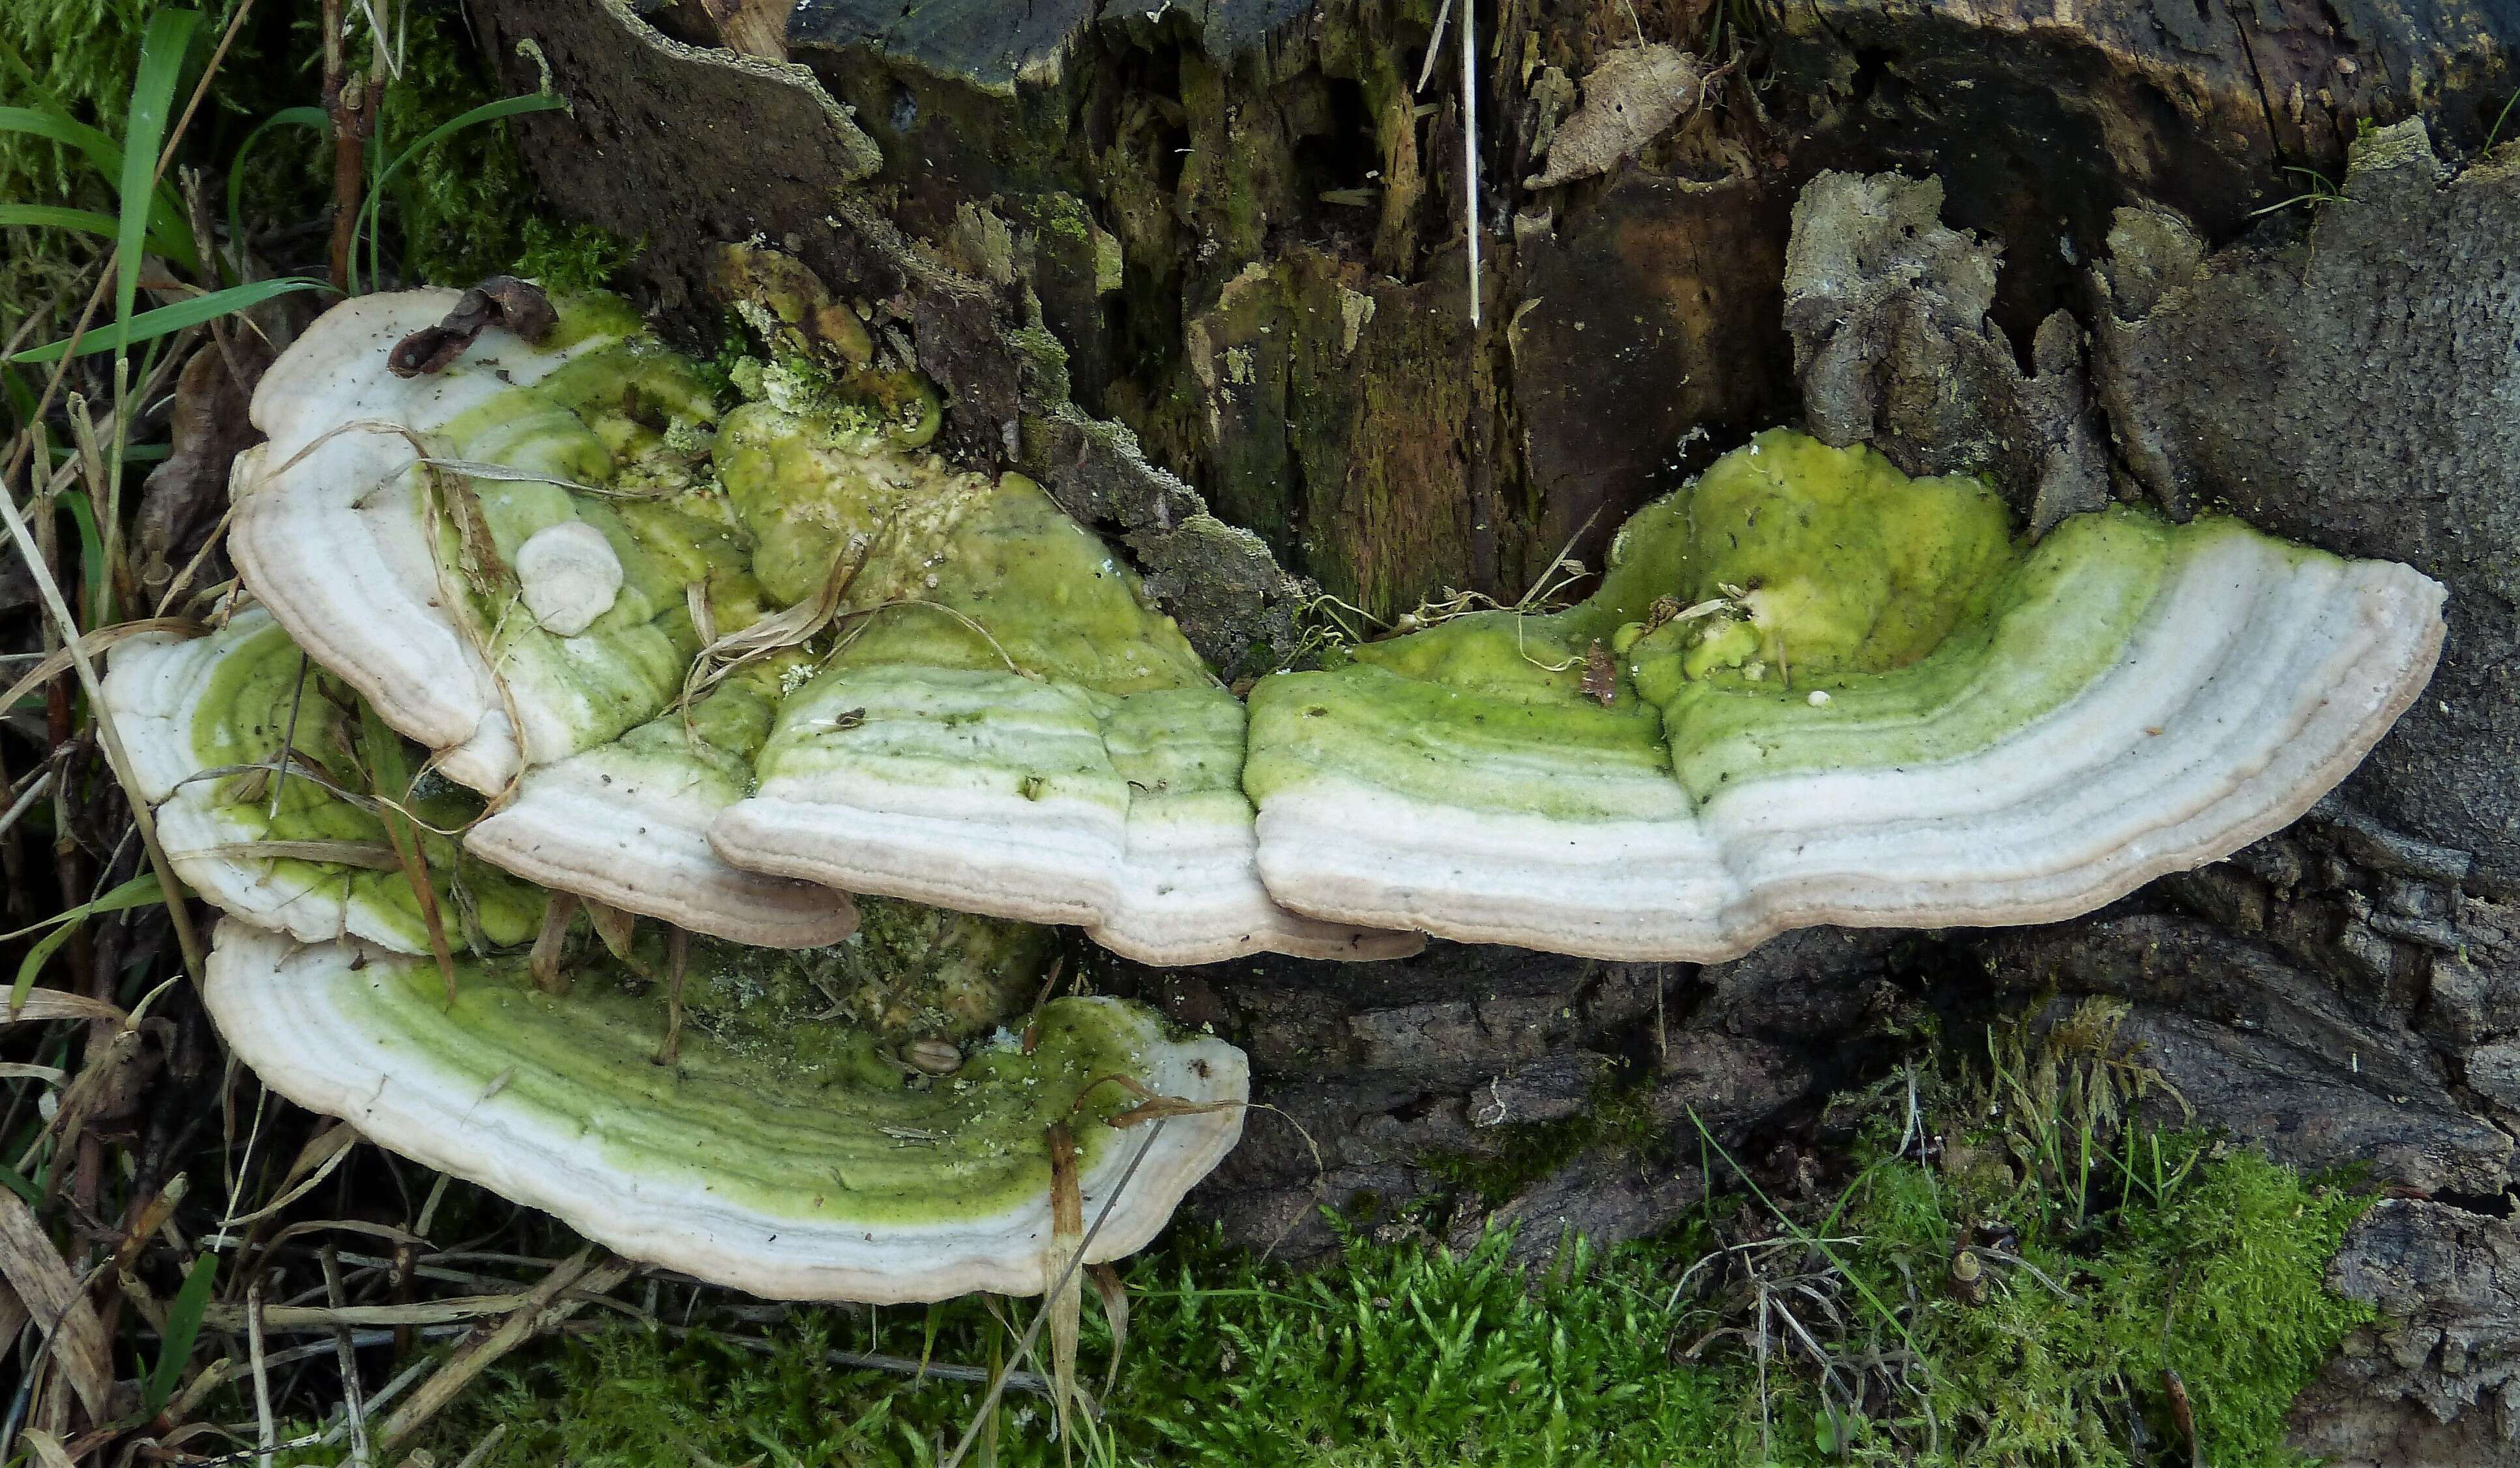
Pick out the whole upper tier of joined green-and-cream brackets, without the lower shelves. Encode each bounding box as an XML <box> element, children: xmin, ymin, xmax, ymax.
<box><xmin>237</xmin><ymin>292</ymin><xmax>2442</xmax><ymax>964</ymax></box>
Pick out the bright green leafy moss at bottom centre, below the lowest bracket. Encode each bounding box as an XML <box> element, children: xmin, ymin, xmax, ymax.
<box><xmin>418</xmin><ymin>1239</ymin><xmax>1751</xmax><ymax>1468</ymax></box>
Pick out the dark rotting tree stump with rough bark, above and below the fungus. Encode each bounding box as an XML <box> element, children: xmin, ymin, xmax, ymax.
<box><xmin>471</xmin><ymin>0</ymin><xmax>2520</xmax><ymax>1463</ymax></box>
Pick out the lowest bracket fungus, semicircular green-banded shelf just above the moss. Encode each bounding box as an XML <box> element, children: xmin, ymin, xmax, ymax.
<box><xmin>204</xmin><ymin>919</ymin><xmax>1247</xmax><ymax>1304</ymax></box>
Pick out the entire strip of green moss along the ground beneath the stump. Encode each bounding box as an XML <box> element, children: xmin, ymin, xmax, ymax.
<box><xmin>403</xmin><ymin>1113</ymin><xmax>2364</xmax><ymax>1468</ymax></box>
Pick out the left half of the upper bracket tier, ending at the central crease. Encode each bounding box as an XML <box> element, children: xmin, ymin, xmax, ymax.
<box><xmin>234</xmin><ymin>292</ymin><xmax>1416</xmax><ymax>962</ymax></box>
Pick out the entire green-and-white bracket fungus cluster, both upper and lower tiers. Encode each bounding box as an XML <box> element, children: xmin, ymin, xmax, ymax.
<box><xmin>138</xmin><ymin>292</ymin><xmax>2442</xmax><ymax>1299</ymax></box>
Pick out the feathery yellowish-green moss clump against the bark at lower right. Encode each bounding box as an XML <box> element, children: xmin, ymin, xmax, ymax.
<box><xmin>1804</xmin><ymin>1118</ymin><xmax>2369</xmax><ymax>1465</ymax></box>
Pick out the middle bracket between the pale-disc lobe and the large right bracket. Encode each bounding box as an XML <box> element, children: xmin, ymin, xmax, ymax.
<box><xmin>711</xmin><ymin>405</ymin><xmax>1416</xmax><ymax>962</ymax></box>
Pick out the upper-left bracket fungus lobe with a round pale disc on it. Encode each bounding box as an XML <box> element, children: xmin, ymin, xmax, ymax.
<box><xmin>230</xmin><ymin>289</ymin><xmax>857</xmax><ymax>947</ymax></box>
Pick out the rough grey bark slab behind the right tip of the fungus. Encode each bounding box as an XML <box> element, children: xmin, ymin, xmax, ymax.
<box><xmin>2097</xmin><ymin>123</ymin><xmax>2520</xmax><ymax>891</ymax></box>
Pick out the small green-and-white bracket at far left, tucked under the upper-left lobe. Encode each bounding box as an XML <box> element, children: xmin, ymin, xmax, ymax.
<box><xmin>106</xmin><ymin>609</ymin><xmax>544</xmax><ymax>954</ymax></box>
